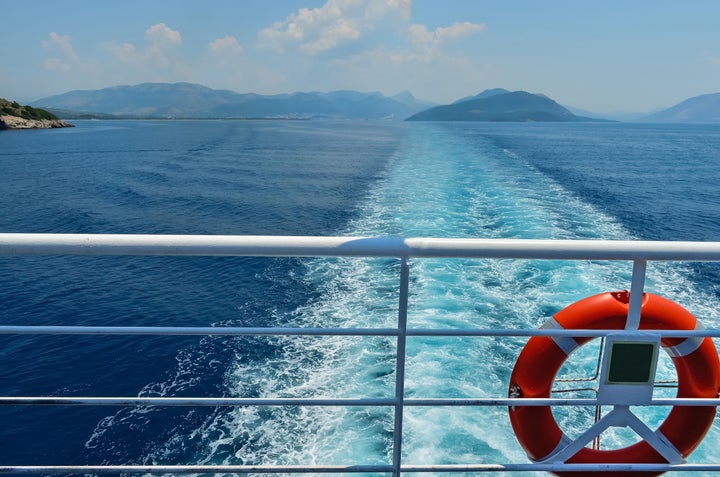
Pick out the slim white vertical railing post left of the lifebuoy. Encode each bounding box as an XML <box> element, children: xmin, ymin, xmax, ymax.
<box><xmin>393</xmin><ymin>257</ymin><xmax>410</xmax><ymax>477</ymax></box>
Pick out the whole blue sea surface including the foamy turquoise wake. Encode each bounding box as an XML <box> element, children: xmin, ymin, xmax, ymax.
<box><xmin>0</xmin><ymin>121</ymin><xmax>720</xmax><ymax>475</ymax></box>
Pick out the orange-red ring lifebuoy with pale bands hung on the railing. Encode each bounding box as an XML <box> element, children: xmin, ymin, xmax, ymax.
<box><xmin>509</xmin><ymin>291</ymin><xmax>720</xmax><ymax>477</ymax></box>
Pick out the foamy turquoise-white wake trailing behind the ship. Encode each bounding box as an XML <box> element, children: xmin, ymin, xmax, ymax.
<box><xmin>118</xmin><ymin>125</ymin><xmax>720</xmax><ymax>475</ymax></box>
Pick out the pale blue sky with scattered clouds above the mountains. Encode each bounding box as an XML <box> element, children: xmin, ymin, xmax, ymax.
<box><xmin>0</xmin><ymin>0</ymin><xmax>720</xmax><ymax>112</ymax></box>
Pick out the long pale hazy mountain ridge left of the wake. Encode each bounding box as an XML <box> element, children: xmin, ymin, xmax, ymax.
<box><xmin>34</xmin><ymin>83</ymin><xmax>429</xmax><ymax>119</ymax></box>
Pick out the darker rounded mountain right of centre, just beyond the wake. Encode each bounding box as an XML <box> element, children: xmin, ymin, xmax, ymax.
<box><xmin>407</xmin><ymin>91</ymin><xmax>596</xmax><ymax>121</ymax></box>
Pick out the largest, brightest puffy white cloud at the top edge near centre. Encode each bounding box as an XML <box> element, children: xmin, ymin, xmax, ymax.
<box><xmin>259</xmin><ymin>0</ymin><xmax>411</xmax><ymax>56</ymax></box>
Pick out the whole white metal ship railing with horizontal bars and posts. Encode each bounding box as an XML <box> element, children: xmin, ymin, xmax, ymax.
<box><xmin>0</xmin><ymin>234</ymin><xmax>720</xmax><ymax>476</ymax></box>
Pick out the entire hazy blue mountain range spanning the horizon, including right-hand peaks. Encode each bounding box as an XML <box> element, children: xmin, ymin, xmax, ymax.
<box><xmin>32</xmin><ymin>83</ymin><xmax>720</xmax><ymax>122</ymax></box>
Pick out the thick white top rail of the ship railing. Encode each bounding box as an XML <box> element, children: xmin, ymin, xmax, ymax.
<box><xmin>0</xmin><ymin>233</ymin><xmax>720</xmax><ymax>261</ymax></box>
